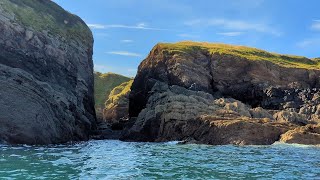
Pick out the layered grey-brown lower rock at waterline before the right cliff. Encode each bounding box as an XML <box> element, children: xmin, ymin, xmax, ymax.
<box><xmin>121</xmin><ymin>82</ymin><xmax>295</xmax><ymax>145</ymax></box>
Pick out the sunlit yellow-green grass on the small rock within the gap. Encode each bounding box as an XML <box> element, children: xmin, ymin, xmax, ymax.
<box><xmin>105</xmin><ymin>80</ymin><xmax>133</xmax><ymax>109</ymax></box>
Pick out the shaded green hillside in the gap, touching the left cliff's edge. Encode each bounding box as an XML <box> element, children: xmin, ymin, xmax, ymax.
<box><xmin>94</xmin><ymin>72</ymin><xmax>131</xmax><ymax>110</ymax></box>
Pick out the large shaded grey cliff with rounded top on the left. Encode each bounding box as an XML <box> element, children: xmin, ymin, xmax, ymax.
<box><xmin>0</xmin><ymin>0</ymin><xmax>96</xmax><ymax>144</ymax></box>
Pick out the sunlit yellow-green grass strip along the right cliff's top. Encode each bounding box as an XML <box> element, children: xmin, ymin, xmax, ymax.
<box><xmin>157</xmin><ymin>41</ymin><xmax>320</xmax><ymax>69</ymax></box>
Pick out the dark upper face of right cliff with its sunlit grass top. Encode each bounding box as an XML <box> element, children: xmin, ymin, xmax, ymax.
<box><xmin>130</xmin><ymin>43</ymin><xmax>320</xmax><ymax>117</ymax></box>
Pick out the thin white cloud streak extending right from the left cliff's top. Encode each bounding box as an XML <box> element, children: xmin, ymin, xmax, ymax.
<box><xmin>88</xmin><ymin>23</ymin><xmax>171</xmax><ymax>31</ymax></box>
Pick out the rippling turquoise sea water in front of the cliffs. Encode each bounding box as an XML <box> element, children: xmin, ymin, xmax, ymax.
<box><xmin>0</xmin><ymin>140</ymin><xmax>320</xmax><ymax>180</ymax></box>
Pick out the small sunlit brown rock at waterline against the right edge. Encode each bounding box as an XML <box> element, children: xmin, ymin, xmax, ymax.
<box><xmin>280</xmin><ymin>124</ymin><xmax>320</xmax><ymax>145</ymax></box>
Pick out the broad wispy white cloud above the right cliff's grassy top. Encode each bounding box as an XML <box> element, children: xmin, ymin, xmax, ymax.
<box><xmin>185</xmin><ymin>18</ymin><xmax>282</xmax><ymax>36</ymax></box>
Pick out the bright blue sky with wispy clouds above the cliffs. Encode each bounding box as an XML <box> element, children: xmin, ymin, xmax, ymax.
<box><xmin>54</xmin><ymin>0</ymin><xmax>320</xmax><ymax>76</ymax></box>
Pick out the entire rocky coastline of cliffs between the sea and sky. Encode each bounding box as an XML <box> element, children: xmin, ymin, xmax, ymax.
<box><xmin>0</xmin><ymin>0</ymin><xmax>320</xmax><ymax>145</ymax></box>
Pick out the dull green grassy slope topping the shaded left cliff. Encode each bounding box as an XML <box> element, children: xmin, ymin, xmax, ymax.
<box><xmin>0</xmin><ymin>0</ymin><xmax>92</xmax><ymax>45</ymax></box>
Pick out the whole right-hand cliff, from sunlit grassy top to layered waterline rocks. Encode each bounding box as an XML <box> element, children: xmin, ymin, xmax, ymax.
<box><xmin>123</xmin><ymin>42</ymin><xmax>320</xmax><ymax>144</ymax></box>
